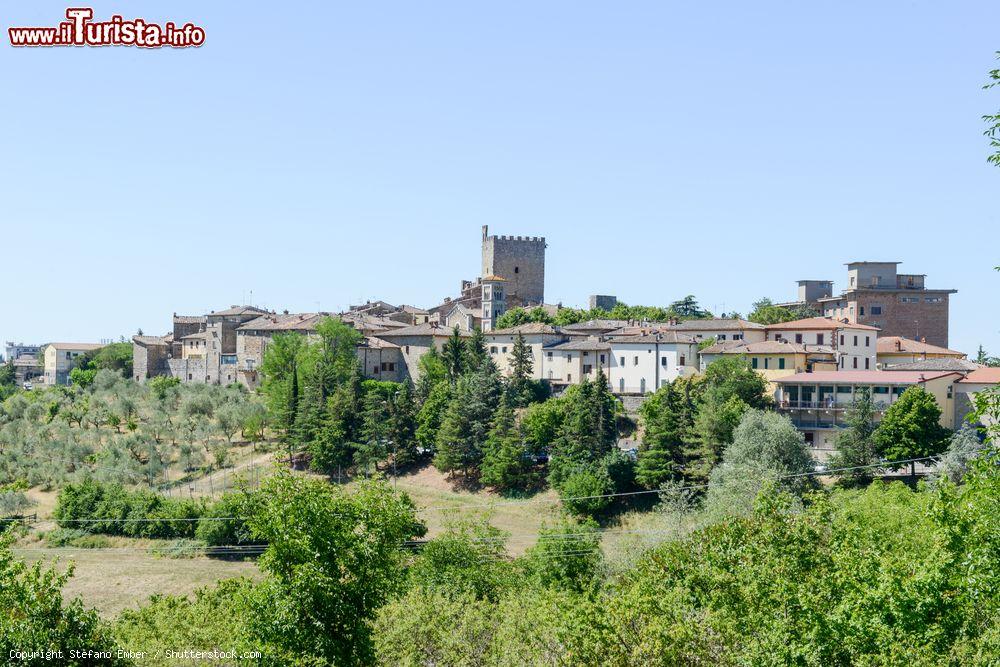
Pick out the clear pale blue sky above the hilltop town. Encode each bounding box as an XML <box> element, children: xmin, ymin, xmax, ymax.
<box><xmin>0</xmin><ymin>0</ymin><xmax>1000</xmax><ymax>354</ymax></box>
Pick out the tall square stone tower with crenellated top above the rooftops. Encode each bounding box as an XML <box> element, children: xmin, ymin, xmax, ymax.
<box><xmin>481</xmin><ymin>225</ymin><xmax>545</xmax><ymax>308</ymax></box>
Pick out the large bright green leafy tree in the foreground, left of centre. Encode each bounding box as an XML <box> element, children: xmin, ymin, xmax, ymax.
<box><xmin>244</xmin><ymin>471</ymin><xmax>424</xmax><ymax>665</ymax></box>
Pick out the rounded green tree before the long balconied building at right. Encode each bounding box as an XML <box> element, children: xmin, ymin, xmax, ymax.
<box><xmin>872</xmin><ymin>386</ymin><xmax>948</xmax><ymax>471</ymax></box>
